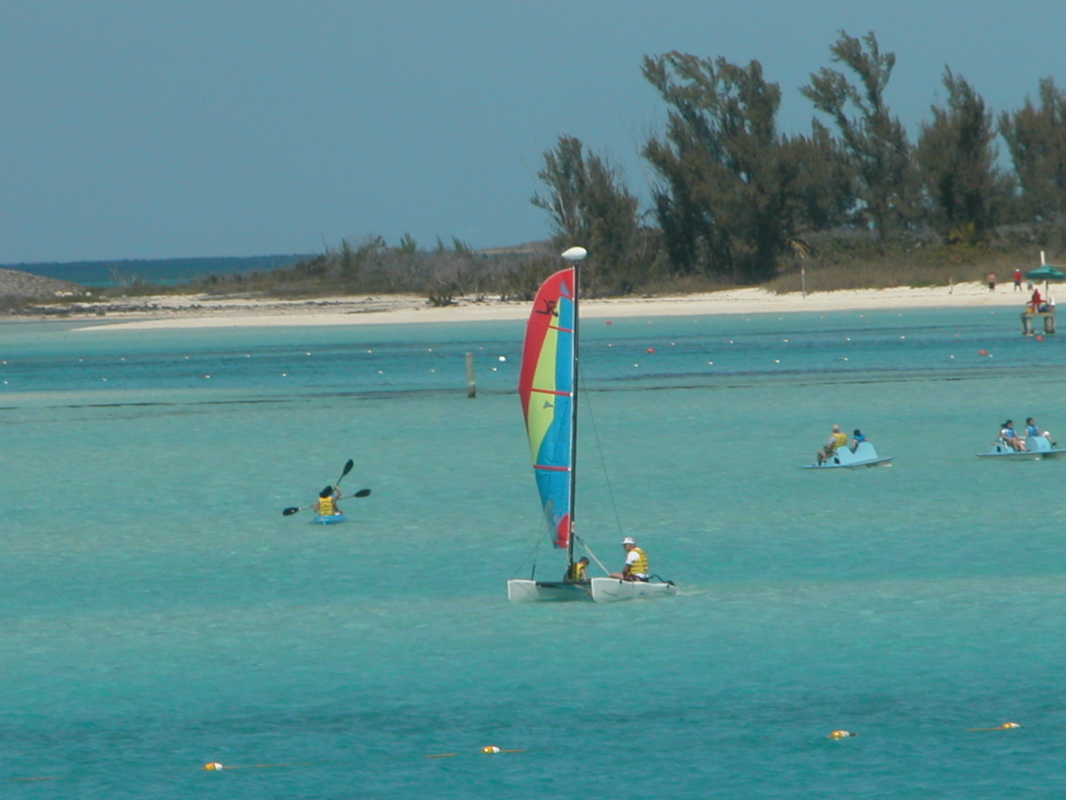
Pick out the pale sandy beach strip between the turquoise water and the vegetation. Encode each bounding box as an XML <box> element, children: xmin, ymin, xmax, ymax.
<box><xmin>10</xmin><ymin>282</ymin><xmax>1048</xmax><ymax>332</ymax></box>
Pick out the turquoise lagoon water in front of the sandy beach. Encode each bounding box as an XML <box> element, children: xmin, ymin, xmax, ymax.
<box><xmin>0</xmin><ymin>310</ymin><xmax>1066</xmax><ymax>800</ymax></box>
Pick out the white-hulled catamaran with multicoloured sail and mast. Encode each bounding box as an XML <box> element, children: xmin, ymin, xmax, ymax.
<box><xmin>507</xmin><ymin>247</ymin><xmax>677</xmax><ymax>603</ymax></box>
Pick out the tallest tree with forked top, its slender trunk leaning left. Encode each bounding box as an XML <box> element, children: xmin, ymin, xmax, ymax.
<box><xmin>800</xmin><ymin>31</ymin><xmax>916</xmax><ymax>241</ymax></box>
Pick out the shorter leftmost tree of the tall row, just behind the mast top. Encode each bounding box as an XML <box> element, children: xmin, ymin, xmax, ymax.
<box><xmin>531</xmin><ymin>135</ymin><xmax>642</xmax><ymax>293</ymax></box>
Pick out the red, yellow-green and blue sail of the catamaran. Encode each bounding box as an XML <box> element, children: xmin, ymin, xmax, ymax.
<box><xmin>518</xmin><ymin>267</ymin><xmax>577</xmax><ymax>547</ymax></box>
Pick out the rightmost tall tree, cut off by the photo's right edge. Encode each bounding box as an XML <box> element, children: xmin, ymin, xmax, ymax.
<box><xmin>999</xmin><ymin>78</ymin><xmax>1066</xmax><ymax>218</ymax></box>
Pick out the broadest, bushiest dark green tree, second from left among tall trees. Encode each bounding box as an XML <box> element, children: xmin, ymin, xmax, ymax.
<box><xmin>642</xmin><ymin>52</ymin><xmax>797</xmax><ymax>283</ymax></box>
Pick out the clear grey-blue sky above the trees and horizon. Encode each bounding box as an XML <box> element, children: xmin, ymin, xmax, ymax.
<box><xmin>0</xmin><ymin>0</ymin><xmax>1066</xmax><ymax>265</ymax></box>
